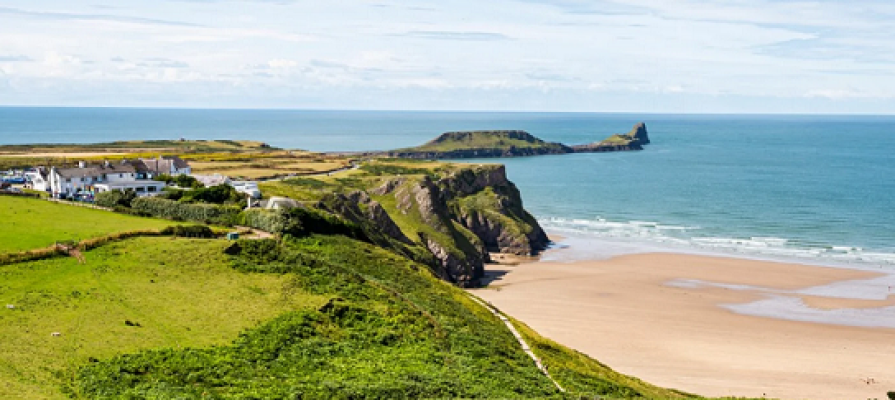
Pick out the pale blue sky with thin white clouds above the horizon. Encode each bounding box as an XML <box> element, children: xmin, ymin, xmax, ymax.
<box><xmin>0</xmin><ymin>0</ymin><xmax>895</xmax><ymax>114</ymax></box>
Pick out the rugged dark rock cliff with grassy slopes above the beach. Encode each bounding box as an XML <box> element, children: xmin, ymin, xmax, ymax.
<box><xmin>320</xmin><ymin>165</ymin><xmax>549</xmax><ymax>287</ymax></box>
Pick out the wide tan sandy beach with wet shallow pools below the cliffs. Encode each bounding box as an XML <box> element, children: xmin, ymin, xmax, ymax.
<box><xmin>475</xmin><ymin>248</ymin><xmax>895</xmax><ymax>399</ymax></box>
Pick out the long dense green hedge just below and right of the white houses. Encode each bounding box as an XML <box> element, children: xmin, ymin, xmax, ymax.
<box><xmin>131</xmin><ymin>197</ymin><xmax>240</xmax><ymax>226</ymax></box>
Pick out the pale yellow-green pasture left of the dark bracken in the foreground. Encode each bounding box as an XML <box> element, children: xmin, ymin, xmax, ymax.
<box><xmin>0</xmin><ymin>238</ymin><xmax>326</xmax><ymax>400</ymax></box>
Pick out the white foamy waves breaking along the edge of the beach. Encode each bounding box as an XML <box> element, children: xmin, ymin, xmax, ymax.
<box><xmin>540</xmin><ymin>218</ymin><xmax>895</xmax><ymax>265</ymax></box>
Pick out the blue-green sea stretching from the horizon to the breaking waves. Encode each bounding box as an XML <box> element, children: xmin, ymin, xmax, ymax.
<box><xmin>0</xmin><ymin>107</ymin><xmax>895</xmax><ymax>269</ymax></box>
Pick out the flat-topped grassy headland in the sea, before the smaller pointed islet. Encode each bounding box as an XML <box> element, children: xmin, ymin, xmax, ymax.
<box><xmin>397</xmin><ymin>131</ymin><xmax>562</xmax><ymax>152</ymax></box>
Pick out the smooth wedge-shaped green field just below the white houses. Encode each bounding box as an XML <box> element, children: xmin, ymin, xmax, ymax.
<box><xmin>0</xmin><ymin>196</ymin><xmax>172</xmax><ymax>253</ymax></box>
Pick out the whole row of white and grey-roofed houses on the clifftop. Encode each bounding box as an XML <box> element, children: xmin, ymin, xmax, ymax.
<box><xmin>25</xmin><ymin>156</ymin><xmax>192</xmax><ymax>198</ymax></box>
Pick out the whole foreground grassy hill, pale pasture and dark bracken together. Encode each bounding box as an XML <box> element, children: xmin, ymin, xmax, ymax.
<box><xmin>10</xmin><ymin>236</ymin><xmax>691</xmax><ymax>399</ymax></box>
